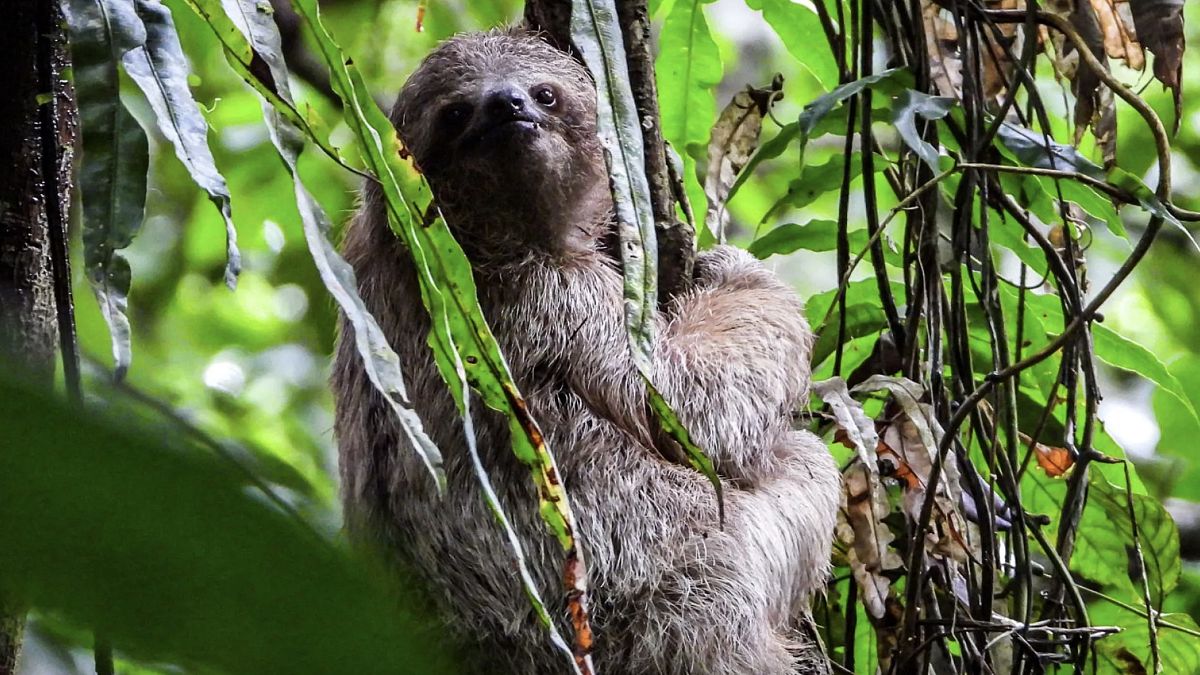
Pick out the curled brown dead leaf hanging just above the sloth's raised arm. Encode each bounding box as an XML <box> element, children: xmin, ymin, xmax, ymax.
<box><xmin>704</xmin><ymin>74</ymin><xmax>784</xmax><ymax>241</ymax></box>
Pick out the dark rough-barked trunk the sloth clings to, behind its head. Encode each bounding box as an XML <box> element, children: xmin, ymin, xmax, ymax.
<box><xmin>524</xmin><ymin>0</ymin><xmax>696</xmax><ymax>299</ymax></box>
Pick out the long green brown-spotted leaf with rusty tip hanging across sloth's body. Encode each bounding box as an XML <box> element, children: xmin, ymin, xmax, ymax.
<box><xmin>264</xmin><ymin>0</ymin><xmax>592</xmax><ymax>673</ymax></box>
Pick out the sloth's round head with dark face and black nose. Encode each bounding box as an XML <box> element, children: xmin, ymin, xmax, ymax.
<box><xmin>392</xmin><ymin>30</ymin><xmax>608</xmax><ymax>254</ymax></box>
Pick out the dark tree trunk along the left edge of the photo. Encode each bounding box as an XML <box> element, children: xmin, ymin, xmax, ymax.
<box><xmin>0</xmin><ymin>0</ymin><xmax>78</xmax><ymax>675</ymax></box>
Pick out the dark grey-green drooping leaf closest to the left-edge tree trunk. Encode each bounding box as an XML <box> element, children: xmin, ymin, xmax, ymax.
<box><xmin>62</xmin><ymin>0</ymin><xmax>150</xmax><ymax>380</ymax></box>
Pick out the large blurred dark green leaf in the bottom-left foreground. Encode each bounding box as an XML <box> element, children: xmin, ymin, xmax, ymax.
<box><xmin>0</xmin><ymin>374</ymin><xmax>458</xmax><ymax>675</ymax></box>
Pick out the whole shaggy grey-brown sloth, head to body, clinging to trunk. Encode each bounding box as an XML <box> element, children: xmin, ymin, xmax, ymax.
<box><xmin>332</xmin><ymin>31</ymin><xmax>840</xmax><ymax>675</ymax></box>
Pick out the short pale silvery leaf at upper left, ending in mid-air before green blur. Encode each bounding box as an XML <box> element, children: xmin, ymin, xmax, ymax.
<box><xmin>124</xmin><ymin>0</ymin><xmax>241</xmax><ymax>288</ymax></box>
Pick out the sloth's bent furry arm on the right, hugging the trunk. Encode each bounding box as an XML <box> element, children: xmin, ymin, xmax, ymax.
<box><xmin>566</xmin><ymin>246</ymin><xmax>812</xmax><ymax>482</ymax></box>
